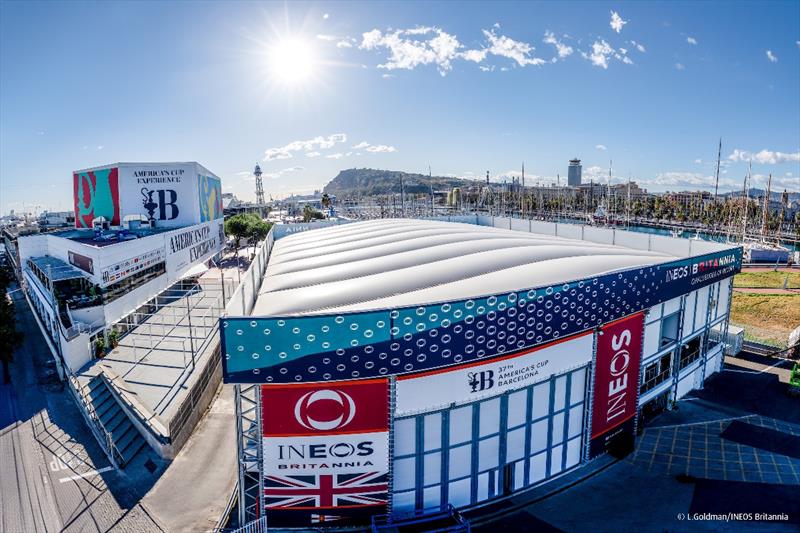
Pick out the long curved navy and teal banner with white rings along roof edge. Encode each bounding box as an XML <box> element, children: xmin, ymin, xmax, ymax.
<box><xmin>220</xmin><ymin>248</ymin><xmax>742</xmax><ymax>383</ymax></box>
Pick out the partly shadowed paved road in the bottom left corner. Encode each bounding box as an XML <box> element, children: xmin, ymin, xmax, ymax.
<box><xmin>0</xmin><ymin>286</ymin><xmax>163</xmax><ymax>533</ymax></box>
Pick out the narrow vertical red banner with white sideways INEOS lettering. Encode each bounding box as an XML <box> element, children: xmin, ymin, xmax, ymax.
<box><xmin>591</xmin><ymin>313</ymin><xmax>644</xmax><ymax>456</ymax></box>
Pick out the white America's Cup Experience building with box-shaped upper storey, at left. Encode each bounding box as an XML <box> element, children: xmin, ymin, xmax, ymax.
<box><xmin>18</xmin><ymin>163</ymin><xmax>225</xmax><ymax>372</ymax></box>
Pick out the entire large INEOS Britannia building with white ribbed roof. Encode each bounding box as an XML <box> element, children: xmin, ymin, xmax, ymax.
<box><xmin>220</xmin><ymin>216</ymin><xmax>742</xmax><ymax>527</ymax></box>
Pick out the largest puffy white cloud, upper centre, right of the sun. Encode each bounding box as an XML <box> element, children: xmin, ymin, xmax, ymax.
<box><xmin>359</xmin><ymin>27</ymin><xmax>462</xmax><ymax>76</ymax></box>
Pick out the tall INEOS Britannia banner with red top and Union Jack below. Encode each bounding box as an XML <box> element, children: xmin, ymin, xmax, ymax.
<box><xmin>261</xmin><ymin>378</ymin><xmax>389</xmax><ymax>528</ymax></box>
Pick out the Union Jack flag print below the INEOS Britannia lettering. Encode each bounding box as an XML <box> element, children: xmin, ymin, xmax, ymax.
<box><xmin>264</xmin><ymin>472</ymin><xmax>389</xmax><ymax>510</ymax></box>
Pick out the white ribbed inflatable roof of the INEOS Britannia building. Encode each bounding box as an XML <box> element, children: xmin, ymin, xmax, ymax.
<box><xmin>252</xmin><ymin>219</ymin><xmax>677</xmax><ymax>316</ymax></box>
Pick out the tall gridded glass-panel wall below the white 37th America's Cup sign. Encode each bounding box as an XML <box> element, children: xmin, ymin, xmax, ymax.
<box><xmin>392</xmin><ymin>367</ymin><xmax>586</xmax><ymax>516</ymax></box>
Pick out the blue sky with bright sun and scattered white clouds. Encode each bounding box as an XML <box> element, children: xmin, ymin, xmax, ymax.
<box><xmin>0</xmin><ymin>1</ymin><xmax>800</xmax><ymax>213</ymax></box>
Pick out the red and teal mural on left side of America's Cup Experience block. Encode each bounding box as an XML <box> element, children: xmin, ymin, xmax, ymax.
<box><xmin>72</xmin><ymin>167</ymin><xmax>120</xmax><ymax>228</ymax></box>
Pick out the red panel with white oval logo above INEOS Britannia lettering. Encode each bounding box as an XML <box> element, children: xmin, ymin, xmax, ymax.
<box><xmin>261</xmin><ymin>379</ymin><xmax>389</xmax><ymax>437</ymax></box>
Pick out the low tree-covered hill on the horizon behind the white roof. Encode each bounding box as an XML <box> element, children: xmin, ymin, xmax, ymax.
<box><xmin>323</xmin><ymin>168</ymin><xmax>476</xmax><ymax>196</ymax></box>
